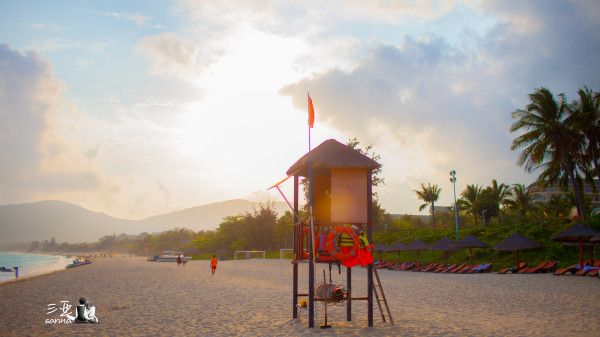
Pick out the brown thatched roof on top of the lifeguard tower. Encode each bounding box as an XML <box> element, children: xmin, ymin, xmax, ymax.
<box><xmin>286</xmin><ymin>139</ymin><xmax>379</xmax><ymax>177</ymax></box>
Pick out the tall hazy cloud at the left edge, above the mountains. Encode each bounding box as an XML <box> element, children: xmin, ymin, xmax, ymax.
<box><xmin>0</xmin><ymin>45</ymin><xmax>115</xmax><ymax>207</ymax></box>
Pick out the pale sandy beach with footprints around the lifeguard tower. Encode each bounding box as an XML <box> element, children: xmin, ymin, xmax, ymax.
<box><xmin>0</xmin><ymin>256</ymin><xmax>600</xmax><ymax>336</ymax></box>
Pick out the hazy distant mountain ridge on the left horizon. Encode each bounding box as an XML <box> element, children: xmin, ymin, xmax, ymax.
<box><xmin>0</xmin><ymin>199</ymin><xmax>288</xmax><ymax>245</ymax></box>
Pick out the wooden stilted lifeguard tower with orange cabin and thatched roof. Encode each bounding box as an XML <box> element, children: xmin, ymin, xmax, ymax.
<box><xmin>287</xmin><ymin>139</ymin><xmax>379</xmax><ymax>328</ymax></box>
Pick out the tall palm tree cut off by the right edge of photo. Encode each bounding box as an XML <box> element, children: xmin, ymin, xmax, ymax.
<box><xmin>569</xmin><ymin>87</ymin><xmax>600</xmax><ymax>185</ymax></box>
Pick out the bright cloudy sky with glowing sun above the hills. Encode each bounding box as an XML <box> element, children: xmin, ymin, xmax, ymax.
<box><xmin>0</xmin><ymin>0</ymin><xmax>600</xmax><ymax>219</ymax></box>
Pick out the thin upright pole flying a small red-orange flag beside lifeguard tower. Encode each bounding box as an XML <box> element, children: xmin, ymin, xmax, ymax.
<box><xmin>307</xmin><ymin>93</ymin><xmax>315</xmax><ymax>328</ymax></box>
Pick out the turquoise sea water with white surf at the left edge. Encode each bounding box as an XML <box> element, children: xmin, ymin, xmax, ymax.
<box><xmin>0</xmin><ymin>253</ymin><xmax>72</xmax><ymax>283</ymax></box>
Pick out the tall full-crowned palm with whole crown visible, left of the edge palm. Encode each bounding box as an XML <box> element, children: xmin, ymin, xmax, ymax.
<box><xmin>510</xmin><ymin>87</ymin><xmax>586</xmax><ymax>220</ymax></box>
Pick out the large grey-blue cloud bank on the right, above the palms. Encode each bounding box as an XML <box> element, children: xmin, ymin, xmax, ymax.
<box><xmin>280</xmin><ymin>1</ymin><xmax>600</xmax><ymax>212</ymax></box>
